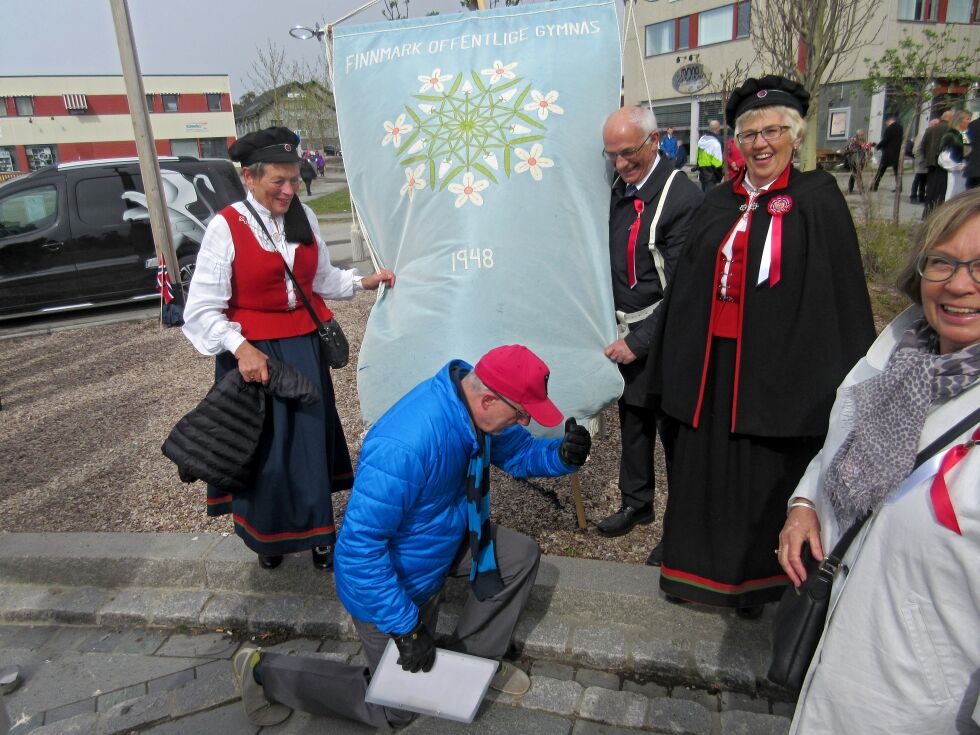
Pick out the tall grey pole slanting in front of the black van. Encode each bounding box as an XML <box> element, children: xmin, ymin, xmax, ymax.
<box><xmin>109</xmin><ymin>0</ymin><xmax>181</xmax><ymax>291</ymax></box>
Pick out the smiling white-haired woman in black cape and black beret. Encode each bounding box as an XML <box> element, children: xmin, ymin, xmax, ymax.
<box><xmin>656</xmin><ymin>76</ymin><xmax>875</xmax><ymax>618</ymax></box>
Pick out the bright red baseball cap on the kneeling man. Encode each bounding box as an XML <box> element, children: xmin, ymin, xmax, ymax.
<box><xmin>473</xmin><ymin>345</ymin><xmax>562</xmax><ymax>426</ymax></box>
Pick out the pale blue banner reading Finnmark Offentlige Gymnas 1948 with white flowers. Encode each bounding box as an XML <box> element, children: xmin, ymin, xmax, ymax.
<box><xmin>333</xmin><ymin>0</ymin><xmax>622</xmax><ymax>431</ymax></box>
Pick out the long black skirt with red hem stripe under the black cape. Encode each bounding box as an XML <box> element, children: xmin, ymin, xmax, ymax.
<box><xmin>660</xmin><ymin>337</ymin><xmax>824</xmax><ymax>607</ymax></box>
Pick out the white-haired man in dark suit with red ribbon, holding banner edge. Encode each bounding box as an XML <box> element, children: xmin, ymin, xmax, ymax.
<box><xmin>597</xmin><ymin>107</ymin><xmax>704</xmax><ymax>563</ymax></box>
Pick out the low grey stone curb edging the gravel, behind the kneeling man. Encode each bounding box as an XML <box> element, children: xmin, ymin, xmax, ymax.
<box><xmin>0</xmin><ymin>533</ymin><xmax>791</xmax><ymax>700</ymax></box>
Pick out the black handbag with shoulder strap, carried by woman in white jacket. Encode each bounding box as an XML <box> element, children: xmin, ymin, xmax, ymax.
<box><xmin>766</xmin><ymin>409</ymin><xmax>980</xmax><ymax>691</ymax></box>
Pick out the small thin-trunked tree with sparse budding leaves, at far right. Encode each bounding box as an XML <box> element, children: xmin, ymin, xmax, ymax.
<box><xmin>864</xmin><ymin>26</ymin><xmax>980</xmax><ymax>224</ymax></box>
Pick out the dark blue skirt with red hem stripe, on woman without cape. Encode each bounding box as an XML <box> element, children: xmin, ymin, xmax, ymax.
<box><xmin>208</xmin><ymin>332</ymin><xmax>354</xmax><ymax>556</ymax></box>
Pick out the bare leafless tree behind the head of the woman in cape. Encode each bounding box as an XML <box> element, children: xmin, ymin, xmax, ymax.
<box><xmin>751</xmin><ymin>0</ymin><xmax>882</xmax><ymax>171</ymax></box>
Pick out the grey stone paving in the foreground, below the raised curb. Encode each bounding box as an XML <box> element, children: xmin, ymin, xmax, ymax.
<box><xmin>0</xmin><ymin>624</ymin><xmax>792</xmax><ymax>735</ymax></box>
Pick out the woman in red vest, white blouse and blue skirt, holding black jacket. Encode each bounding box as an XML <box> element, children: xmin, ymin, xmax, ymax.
<box><xmin>184</xmin><ymin>127</ymin><xmax>395</xmax><ymax>569</ymax></box>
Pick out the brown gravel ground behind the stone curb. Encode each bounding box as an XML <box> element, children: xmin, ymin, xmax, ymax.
<box><xmin>0</xmin><ymin>293</ymin><xmax>666</xmax><ymax>562</ymax></box>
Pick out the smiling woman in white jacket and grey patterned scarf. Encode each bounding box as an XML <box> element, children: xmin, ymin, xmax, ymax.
<box><xmin>776</xmin><ymin>190</ymin><xmax>980</xmax><ymax>735</ymax></box>
